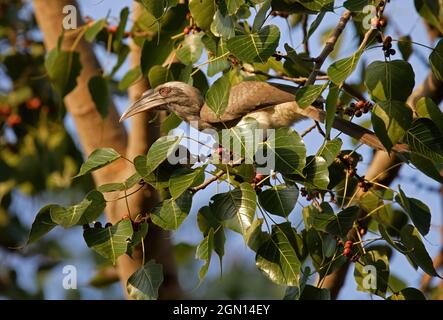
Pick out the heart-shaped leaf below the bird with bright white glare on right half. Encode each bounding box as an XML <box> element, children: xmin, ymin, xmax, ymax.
<box><xmin>209</xmin><ymin>182</ymin><xmax>256</xmax><ymax>236</ymax></box>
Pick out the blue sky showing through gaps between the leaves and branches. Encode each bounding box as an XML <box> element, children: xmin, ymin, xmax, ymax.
<box><xmin>21</xmin><ymin>0</ymin><xmax>442</xmax><ymax>299</ymax></box>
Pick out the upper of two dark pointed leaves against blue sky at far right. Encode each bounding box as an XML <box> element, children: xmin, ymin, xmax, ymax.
<box><xmin>395</xmin><ymin>186</ymin><xmax>431</xmax><ymax>235</ymax></box>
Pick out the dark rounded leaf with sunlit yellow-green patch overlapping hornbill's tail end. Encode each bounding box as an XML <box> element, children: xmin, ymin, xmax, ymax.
<box><xmin>371</xmin><ymin>100</ymin><xmax>413</xmax><ymax>151</ymax></box>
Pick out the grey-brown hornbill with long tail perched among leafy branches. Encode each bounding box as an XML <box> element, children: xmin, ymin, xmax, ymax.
<box><xmin>120</xmin><ymin>81</ymin><xmax>408</xmax><ymax>153</ymax></box>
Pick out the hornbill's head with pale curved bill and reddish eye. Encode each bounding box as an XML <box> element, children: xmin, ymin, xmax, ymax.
<box><xmin>120</xmin><ymin>81</ymin><xmax>204</xmax><ymax>122</ymax></box>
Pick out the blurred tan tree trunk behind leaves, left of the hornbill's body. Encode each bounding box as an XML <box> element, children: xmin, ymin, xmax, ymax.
<box><xmin>33</xmin><ymin>0</ymin><xmax>182</xmax><ymax>299</ymax></box>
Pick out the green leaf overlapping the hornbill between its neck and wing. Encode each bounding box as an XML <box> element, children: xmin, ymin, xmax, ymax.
<box><xmin>206</xmin><ymin>74</ymin><xmax>231</xmax><ymax>116</ymax></box>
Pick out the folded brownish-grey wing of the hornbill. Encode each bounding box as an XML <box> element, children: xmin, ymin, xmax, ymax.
<box><xmin>200</xmin><ymin>81</ymin><xmax>296</xmax><ymax>126</ymax></box>
